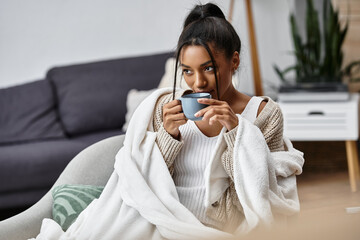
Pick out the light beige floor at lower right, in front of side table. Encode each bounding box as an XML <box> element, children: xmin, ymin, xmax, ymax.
<box><xmin>239</xmin><ymin>172</ymin><xmax>360</xmax><ymax>240</ymax></box>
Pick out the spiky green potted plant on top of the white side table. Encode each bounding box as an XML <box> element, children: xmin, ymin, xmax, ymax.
<box><xmin>274</xmin><ymin>0</ymin><xmax>360</xmax><ymax>92</ymax></box>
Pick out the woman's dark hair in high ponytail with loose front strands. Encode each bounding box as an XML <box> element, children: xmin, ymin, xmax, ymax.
<box><xmin>173</xmin><ymin>3</ymin><xmax>241</xmax><ymax>99</ymax></box>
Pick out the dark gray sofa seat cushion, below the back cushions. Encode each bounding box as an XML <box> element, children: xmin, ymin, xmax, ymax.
<box><xmin>0</xmin><ymin>139</ymin><xmax>88</xmax><ymax>195</ymax></box>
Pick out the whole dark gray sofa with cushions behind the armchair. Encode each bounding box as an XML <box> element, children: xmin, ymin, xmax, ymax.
<box><xmin>0</xmin><ymin>53</ymin><xmax>173</xmax><ymax>211</ymax></box>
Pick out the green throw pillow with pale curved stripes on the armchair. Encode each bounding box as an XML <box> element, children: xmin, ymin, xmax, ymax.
<box><xmin>52</xmin><ymin>184</ymin><xmax>104</xmax><ymax>231</ymax></box>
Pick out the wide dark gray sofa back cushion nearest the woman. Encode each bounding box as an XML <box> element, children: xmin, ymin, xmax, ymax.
<box><xmin>47</xmin><ymin>53</ymin><xmax>172</xmax><ymax>135</ymax></box>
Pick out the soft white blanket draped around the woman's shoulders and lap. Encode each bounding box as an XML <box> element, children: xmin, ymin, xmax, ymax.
<box><xmin>32</xmin><ymin>89</ymin><xmax>304</xmax><ymax>240</ymax></box>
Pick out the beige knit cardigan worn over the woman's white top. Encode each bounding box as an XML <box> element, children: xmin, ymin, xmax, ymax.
<box><xmin>153</xmin><ymin>93</ymin><xmax>284</xmax><ymax>232</ymax></box>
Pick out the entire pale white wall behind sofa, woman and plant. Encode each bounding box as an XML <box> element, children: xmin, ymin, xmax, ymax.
<box><xmin>0</xmin><ymin>0</ymin><xmax>293</xmax><ymax>96</ymax></box>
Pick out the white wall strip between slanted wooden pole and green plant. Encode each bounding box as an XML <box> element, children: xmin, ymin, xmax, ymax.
<box><xmin>249</xmin><ymin>0</ymin><xmax>296</xmax><ymax>96</ymax></box>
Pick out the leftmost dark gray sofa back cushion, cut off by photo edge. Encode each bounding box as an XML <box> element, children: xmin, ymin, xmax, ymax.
<box><xmin>0</xmin><ymin>80</ymin><xmax>64</xmax><ymax>144</ymax></box>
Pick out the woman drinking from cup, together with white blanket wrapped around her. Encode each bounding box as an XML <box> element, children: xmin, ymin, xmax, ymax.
<box><xmin>28</xmin><ymin>4</ymin><xmax>304</xmax><ymax>240</ymax></box>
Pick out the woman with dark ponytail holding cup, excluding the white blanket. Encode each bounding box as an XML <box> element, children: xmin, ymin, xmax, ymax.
<box><xmin>154</xmin><ymin>3</ymin><xmax>290</xmax><ymax>231</ymax></box>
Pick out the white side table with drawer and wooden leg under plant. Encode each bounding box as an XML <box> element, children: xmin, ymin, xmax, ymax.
<box><xmin>279</xmin><ymin>94</ymin><xmax>360</xmax><ymax>192</ymax></box>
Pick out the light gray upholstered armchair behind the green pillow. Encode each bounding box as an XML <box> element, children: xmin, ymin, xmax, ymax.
<box><xmin>0</xmin><ymin>135</ymin><xmax>125</xmax><ymax>240</ymax></box>
